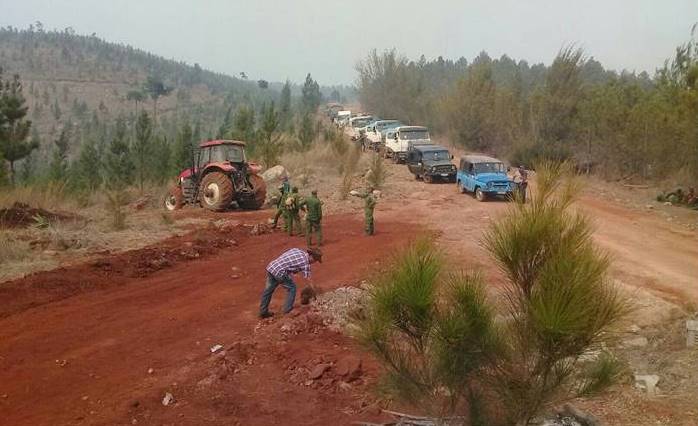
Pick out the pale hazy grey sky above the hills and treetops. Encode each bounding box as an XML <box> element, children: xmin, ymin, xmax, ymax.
<box><xmin>0</xmin><ymin>0</ymin><xmax>698</xmax><ymax>84</ymax></box>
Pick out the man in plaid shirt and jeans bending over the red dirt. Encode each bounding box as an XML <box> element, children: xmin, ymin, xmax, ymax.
<box><xmin>259</xmin><ymin>248</ymin><xmax>322</xmax><ymax>318</ymax></box>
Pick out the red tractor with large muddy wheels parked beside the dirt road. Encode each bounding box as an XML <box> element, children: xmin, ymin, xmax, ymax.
<box><xmin>165</xmin><ymin>140</ymin><xmax>267</xmax><ymax>211</ymax></box>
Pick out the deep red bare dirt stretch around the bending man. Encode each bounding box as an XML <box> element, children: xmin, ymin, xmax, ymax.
<box><xmin>0</xmin><ymin>212</ymin><xmax>409</xmax><ymax>426</ymax></box>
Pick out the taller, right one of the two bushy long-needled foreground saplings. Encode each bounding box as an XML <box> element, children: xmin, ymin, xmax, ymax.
<box><xmin>484</xmin><ymin>163</ymin><xmax>628</xmax><ymax>424</ymax></box>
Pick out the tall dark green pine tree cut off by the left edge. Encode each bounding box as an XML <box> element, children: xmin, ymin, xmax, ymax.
<box><xmin>0</xmin><ymin>68</ymin><xmax>39</xmax><ymax>185</ymax></box>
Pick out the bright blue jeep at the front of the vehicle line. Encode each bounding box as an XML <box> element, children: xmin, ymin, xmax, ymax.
<box><xmin>456</xmin><ymin>155</ymin><xmax>514</xmax><ymax>201</ymax></box>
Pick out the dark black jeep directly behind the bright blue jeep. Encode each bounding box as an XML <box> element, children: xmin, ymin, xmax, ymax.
<box><xmin>406</xmin><ymin>145</ymin><xmax>456</xmax><ymax>183</ymax></box>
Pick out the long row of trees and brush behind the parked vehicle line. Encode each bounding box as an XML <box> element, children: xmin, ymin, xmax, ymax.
<box><xmin>357</xmin><ymin>27</ymin><xmax>698</xmax><ymax>184</ymax></box>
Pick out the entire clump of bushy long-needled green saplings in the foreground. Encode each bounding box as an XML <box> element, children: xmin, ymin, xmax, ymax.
<box><xmin>355</xmin><ymin>163</ymin><xmax>629</xmax><ymax>425</ymax></box>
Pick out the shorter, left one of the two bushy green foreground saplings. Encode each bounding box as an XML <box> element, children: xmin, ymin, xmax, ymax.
<box><xmin>354</xmin><ymin>238</ymin><xmax>500</xmax><ymax>419</ymax></box>
